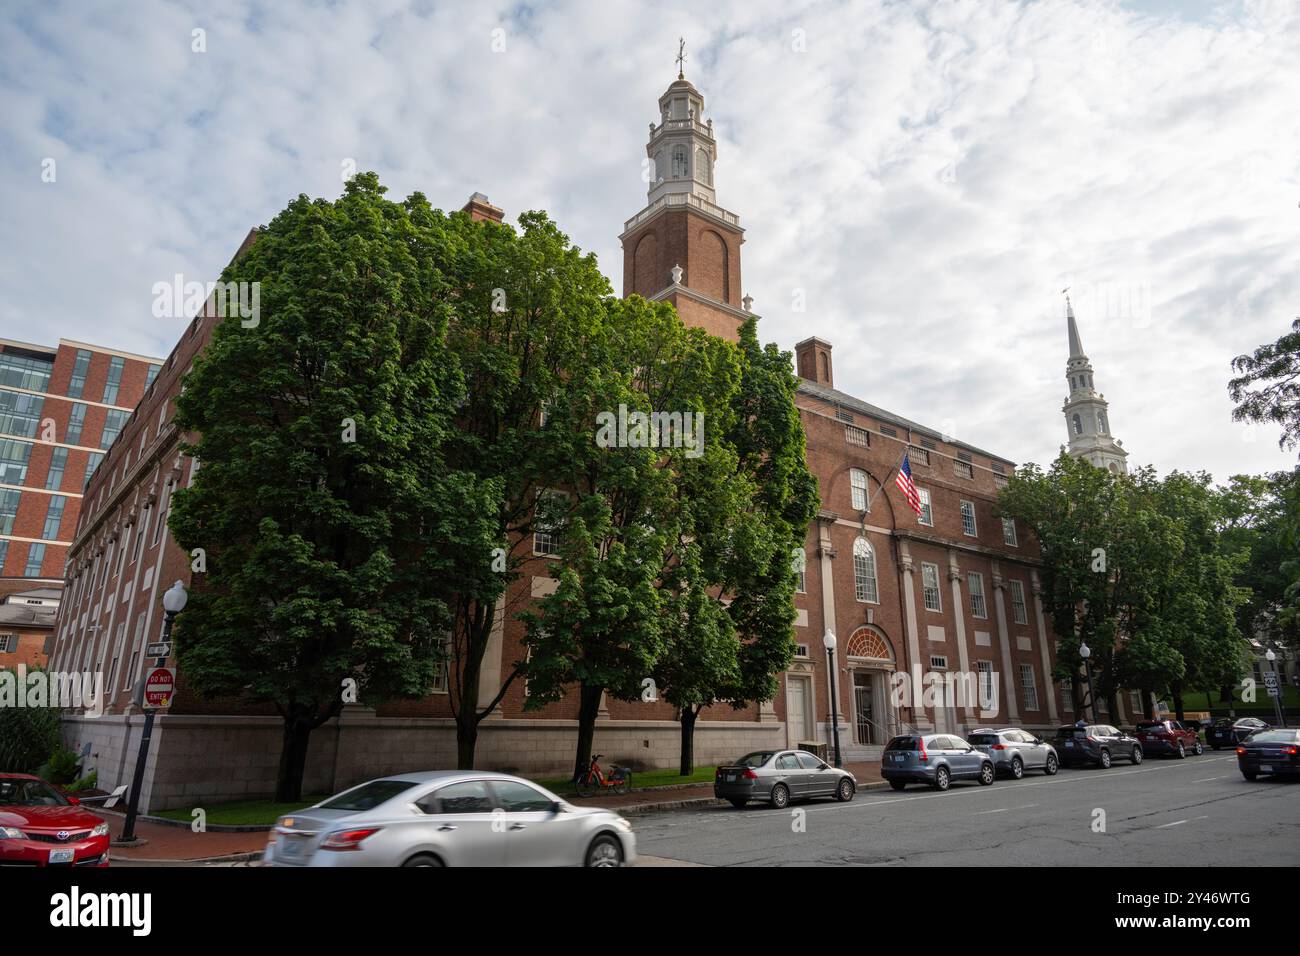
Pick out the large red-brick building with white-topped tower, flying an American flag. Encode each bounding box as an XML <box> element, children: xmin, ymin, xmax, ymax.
<box><xmin>55</xmin><ymin>77</ymin><xmax>1138</xmax><ymax>808</ymax></box>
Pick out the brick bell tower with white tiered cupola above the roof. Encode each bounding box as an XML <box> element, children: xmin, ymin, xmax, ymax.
<box><xmin>619</xmin><ymin>60</ymin><xmax>751</xmax><ymax>342</ymax></box>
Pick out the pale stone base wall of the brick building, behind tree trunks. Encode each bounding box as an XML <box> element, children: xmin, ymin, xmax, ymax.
<box><xmin>64</xmin><ymin>710</ymin><xmax>785</xmax><ymax>810</ymax></box>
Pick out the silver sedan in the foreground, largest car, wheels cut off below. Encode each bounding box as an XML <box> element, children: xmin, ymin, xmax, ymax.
<box><xmin>263</xmin><ymin>770</ymin><xmax>636</xmax><ymax>866</ymax></box>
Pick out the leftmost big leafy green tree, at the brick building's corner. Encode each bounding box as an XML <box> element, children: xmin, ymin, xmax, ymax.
<box><xmin>170</xmin><ymin>173</ymin><xmax>499</xmax><ymax>801</ymax></box>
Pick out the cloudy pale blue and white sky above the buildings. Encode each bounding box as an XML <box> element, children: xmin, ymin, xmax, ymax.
<box><xmin>0</xmin><ymin>0</ymin><xmax>1300</xmax><ymax>480</ymax></box>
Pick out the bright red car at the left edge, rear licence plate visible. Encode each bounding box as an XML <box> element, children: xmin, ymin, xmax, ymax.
<box><xmin>0</xmin><ymin>774</ymin><xmax>109</xmax><ymax>866</ymax></box>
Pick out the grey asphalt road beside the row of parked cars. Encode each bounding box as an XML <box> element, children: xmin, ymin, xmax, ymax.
<box><xmin>633</xmin><ymin>750</ymin><xmax>1300</xmax><ymax>866</ymax></box>
